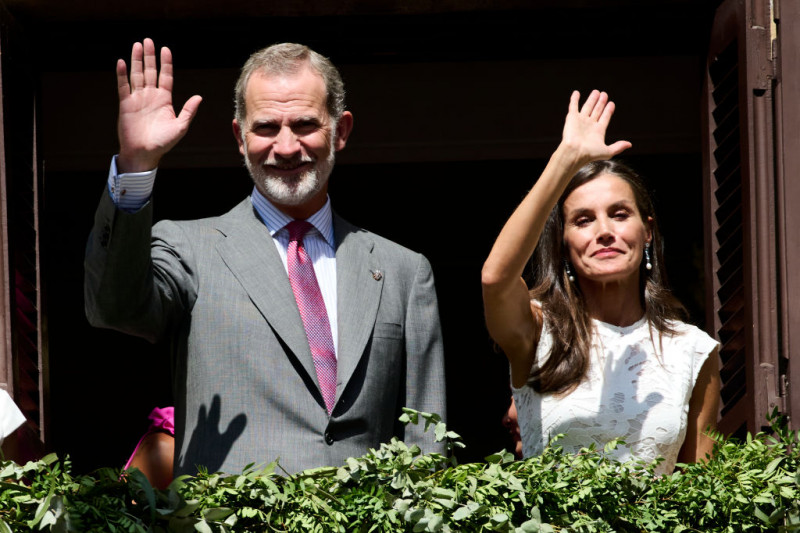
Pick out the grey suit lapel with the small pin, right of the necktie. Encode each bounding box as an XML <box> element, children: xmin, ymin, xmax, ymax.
<box><xmin>333</xmin><ymin>214</ymin><xmax>383</xmax><ymax>400</ymax></box>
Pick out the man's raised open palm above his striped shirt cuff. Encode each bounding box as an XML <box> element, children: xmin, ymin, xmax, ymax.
<box><xmin>117</xmin><ymin>39</ymin><xmax>202</xmax><ymax>173</ymax></box>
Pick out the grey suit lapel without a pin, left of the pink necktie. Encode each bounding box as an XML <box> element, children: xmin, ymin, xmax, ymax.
<box><xmin>217</xmin><ymin>198</ymin><xmax>317</xmax><ymax>383</ymax></box>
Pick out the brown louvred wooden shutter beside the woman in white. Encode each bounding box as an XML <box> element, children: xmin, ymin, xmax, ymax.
<box><xmin>703</xmin><ymin>0</ymin><xmax>784</xmax><ymax>434</ymax></box>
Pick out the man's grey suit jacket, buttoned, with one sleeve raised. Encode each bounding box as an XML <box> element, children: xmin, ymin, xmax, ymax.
<box><xmin>85</xmin><ymin>193</ymin><xmax>445</xmax><ymax>475</ymax></box>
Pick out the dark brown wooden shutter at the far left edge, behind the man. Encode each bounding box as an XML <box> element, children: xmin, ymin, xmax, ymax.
<box><xmin>0</xmin><ymin>4</ymin><xmax>48</xmax><ymax>448</ymax></box>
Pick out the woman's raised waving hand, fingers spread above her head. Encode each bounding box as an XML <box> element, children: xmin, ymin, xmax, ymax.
<box><xmin>561</xmin><ymin>90</ymin><xmax>631</xmax><ymax>166</ymax></box>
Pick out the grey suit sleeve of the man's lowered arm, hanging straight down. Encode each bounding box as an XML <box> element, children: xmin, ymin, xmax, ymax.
<box><xmin>405</xmin><ymin>255</ymin><xmax>447</xmax><ymax>453</ymax></box>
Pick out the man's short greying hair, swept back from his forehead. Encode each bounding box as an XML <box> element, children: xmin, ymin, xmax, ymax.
<box><xmin>234</xmin><ymin>43</ymin><xmax>344</xmax><ymax>128</ymax></box>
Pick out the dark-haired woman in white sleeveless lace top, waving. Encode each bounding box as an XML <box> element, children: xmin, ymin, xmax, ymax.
<box><xmin>482</xmin><ymin>91</ymin><xmax>719</xmax><ymax>473</ymax></box>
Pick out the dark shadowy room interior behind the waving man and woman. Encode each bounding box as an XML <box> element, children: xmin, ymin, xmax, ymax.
<box><xmin>3</xmin><ymin>0</ymin><xmax>713</xmax><ymax>471</ymax></box>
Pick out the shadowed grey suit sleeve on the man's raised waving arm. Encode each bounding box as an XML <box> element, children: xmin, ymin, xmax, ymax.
<box><xmin>84</xmin><ymin>191</ymin><xmax>197</xmax><ymax>342</ymax></box>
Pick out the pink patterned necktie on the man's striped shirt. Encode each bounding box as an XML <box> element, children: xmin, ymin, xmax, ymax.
<box><xmin>286</xmin><ymin>220</ymin><xmax>336</xmax><ymax>414</ymax></box>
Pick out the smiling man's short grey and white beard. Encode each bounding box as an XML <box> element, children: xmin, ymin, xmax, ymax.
<box><xmin>244</xmin><ymin>149</ymin><xmax>336</xmax><ymax>206</ymax></box>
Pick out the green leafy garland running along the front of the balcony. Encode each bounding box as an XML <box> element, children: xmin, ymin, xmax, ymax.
<box><xmin>0</xmin><ymin>410</ymin><xmax>800</xmax><ymax>533</ymax></box>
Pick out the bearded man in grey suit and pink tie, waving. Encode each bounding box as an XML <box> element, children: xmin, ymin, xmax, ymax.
<box><xmin>85</xmin><ymin>39</ymin><xmax>445</xmax><ymax>475</ymax></box>
